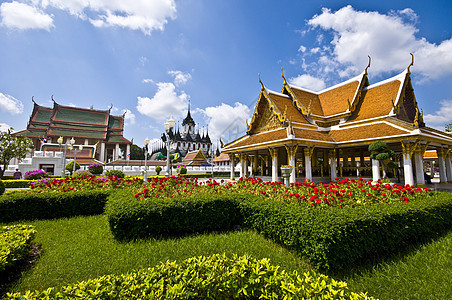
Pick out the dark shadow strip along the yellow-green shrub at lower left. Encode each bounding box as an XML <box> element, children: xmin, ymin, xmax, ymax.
<box><xmin>0</xmin><ymin>244</ymin><xmax>42</xmax><ymax>299</ymax></box>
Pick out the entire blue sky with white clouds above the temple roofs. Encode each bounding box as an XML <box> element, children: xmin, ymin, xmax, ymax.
<box><xmin>0</xmin><ymin>0</ymin><xmax>452</xmax><ymax>149</ymax></box>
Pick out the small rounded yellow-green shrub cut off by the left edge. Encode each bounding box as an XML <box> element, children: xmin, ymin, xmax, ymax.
<box><xmin>0</xmin><ymin>225</ymin><xmax>35</xmax><ymax>272</ymax></box>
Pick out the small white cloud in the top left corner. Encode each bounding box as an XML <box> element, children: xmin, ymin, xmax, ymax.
<box><xmin>0</xmin><ymin>1</ymin><xmax>54</xmax><ymax>31</ymax></box>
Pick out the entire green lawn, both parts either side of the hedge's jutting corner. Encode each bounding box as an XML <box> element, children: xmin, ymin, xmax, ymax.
<box><xmin>4</xmin><ymin>215</ymin><xmax>452</xmax><ymax>299</ymax></box>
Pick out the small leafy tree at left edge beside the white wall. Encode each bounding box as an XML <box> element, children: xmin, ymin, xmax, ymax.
<box><xmin>0</xmin><ymin>130</ymin><xmax>33</xmax><ymax>178</ymax></box>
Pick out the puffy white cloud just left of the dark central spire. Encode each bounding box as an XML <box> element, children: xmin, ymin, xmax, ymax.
<box><xmin>137</xmin><ymin>82</ymin><xmax>189</xmax><ymax>122</ymax></box>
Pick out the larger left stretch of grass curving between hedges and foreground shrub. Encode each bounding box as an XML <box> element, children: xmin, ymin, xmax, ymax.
<box><xmin>12</xmin><ymin>215</ymin><xmax>310</xmax><ymax>292</ymax></box>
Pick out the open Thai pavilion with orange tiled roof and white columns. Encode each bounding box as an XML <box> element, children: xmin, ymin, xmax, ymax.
<box><xmin>223</xmin><ymin>57</ymin><xmax>452</xmax><ymax>186</ymax></box>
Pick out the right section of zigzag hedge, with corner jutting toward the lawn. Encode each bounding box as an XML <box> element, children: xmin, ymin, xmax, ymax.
<box><xmin>240</xmin><ymin>193</ymin><xmax>452</xmax><ymax>270</ymax></box>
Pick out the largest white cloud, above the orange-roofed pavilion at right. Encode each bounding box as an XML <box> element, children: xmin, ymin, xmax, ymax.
<box><xmin>308</xmin><ymin>6</ymin><xmax>452</xmax><ymax>79</ymax></box>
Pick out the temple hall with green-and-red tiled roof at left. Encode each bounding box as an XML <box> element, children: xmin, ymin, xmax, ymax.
<box><xmin>15</xmin><ymin>98</ymin><xmax>132</xmax><ymax>163</ymax></box>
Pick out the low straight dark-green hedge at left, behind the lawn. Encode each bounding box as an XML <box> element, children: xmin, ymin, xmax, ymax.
<box><xmin>0</xmin><ymin>190</ymin><xmax>110</xmax><ymax>222</ymax></box>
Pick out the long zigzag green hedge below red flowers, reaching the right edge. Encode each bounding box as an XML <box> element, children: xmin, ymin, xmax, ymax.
<box><xmin>106</xmin><ymin>191</ymin><xmax>452</xmax><ymax>270</ymax></box>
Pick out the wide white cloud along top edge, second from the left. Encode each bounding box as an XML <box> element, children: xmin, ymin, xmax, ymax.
<box><xmin>40</xmin><ymin>0</ymin><xmax>176</xmax><ymax>34</ymax></box>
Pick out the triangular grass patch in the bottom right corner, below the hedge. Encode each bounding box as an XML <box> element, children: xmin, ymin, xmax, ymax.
<box><xmin>340</xmin><ymin>232</ymin><xmax>452</xmax><ymax>299</ymax></box>
